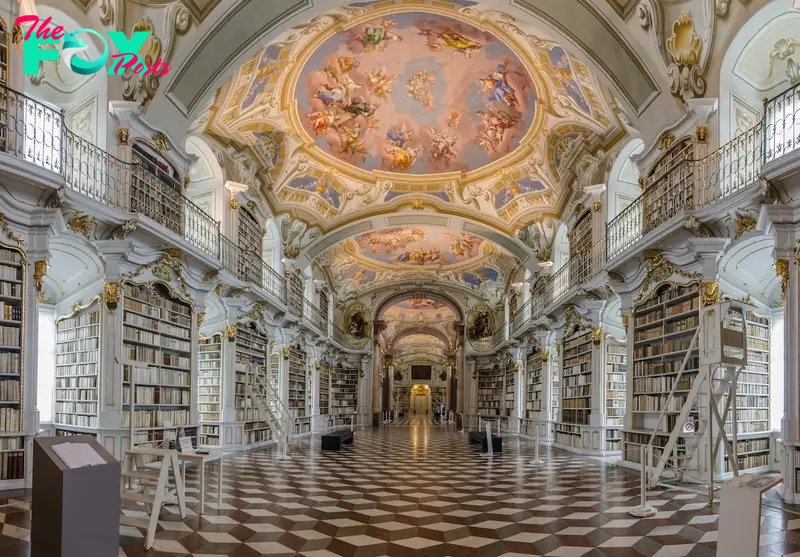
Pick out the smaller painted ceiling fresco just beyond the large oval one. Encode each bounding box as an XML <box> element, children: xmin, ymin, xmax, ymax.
<box><xmin>318</xmin><ymin>226</ymin><xmax>520</xmax><ymax>298</ymax></box>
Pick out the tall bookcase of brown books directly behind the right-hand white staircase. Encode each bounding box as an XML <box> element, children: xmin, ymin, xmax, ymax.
<box><xmin>622</xmin><ymin>283</ymin><xmax>700</xmax><ymax>470</ymax></box>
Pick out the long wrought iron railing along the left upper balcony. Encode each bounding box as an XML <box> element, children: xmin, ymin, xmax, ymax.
<box><xmin>0</xmin><ymin>86</ymin><xmax>286</xmax><ymax>303</ymax></box>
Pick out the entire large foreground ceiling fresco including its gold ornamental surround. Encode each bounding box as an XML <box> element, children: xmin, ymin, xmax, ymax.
<box><xmin>200</xmin><ymin>0</ymin><xmax>625</xmax><ymax>236</ymax></box>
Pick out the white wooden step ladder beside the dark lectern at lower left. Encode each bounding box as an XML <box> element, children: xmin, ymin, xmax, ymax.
<box><xmin>120</xmin><ymin>448</ymin><xmax>186</xmax><ymax>550</ymax></box>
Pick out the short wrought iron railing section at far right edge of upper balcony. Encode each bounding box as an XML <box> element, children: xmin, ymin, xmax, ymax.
<box><xmin>764</xmin><ymin>83</ymin><xmax>800</xmax><ymax>163</ymax></box>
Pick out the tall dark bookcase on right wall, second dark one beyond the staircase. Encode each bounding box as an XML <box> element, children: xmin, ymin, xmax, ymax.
<box><xmin>555</xmin><ymin>330</ymin><xmax>592</xmax><ymax>447</ymax></box>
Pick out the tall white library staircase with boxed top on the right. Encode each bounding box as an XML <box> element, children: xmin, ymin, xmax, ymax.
<box><xmin>642</xmin><ymin>301</ymin><xmax>747</xmax><ymax>493</ymax></box>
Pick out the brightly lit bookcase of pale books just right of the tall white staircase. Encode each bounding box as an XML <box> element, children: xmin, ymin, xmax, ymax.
<box><xmin>720</xmin><ymin>311</ymin><xmax>772</xmax><ymax>473</ymax></box>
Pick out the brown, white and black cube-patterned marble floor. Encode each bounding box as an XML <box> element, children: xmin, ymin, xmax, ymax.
<box><xmin>0</xmin><ymin>421</ymin><xmax>800</xmax><ymax>557</ymax></box>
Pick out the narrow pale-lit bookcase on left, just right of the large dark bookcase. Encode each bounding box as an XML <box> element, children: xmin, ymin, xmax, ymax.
<box><xmin>197</xmin><ymin>333</ymin><xmax>223</xmax><ymax>447</ymax></box>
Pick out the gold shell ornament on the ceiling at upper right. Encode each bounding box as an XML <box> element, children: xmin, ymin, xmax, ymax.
<box><xmin>666</xmin><ymin>13</ymin><xmax>706</xmax><ymax>99</ymax></box>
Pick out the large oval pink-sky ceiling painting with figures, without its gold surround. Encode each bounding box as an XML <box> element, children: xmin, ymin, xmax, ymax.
<box><xmin>296</xmin><ymin>12</ymin><xmax>536</xmax><ymax>174</ymax></box>
